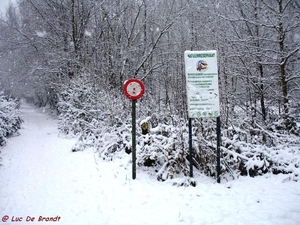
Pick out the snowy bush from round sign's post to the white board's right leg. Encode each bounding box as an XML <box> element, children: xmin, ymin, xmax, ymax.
<box><xmin>137</xmin><ymin>116</ymin><xmax>225</xmax><ymax>181</ymax></box>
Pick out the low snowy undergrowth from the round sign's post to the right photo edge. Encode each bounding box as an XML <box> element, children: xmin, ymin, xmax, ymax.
<box><xmin>138</xmin><ymin>115</ymin><xmax>300</xmax><ymax>181</ymax></box>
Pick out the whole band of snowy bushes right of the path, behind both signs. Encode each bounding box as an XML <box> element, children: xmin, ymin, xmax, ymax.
<box><xmin>59</xmin><ymin>80</ymin><xmax>300</xmax><ymax>181</ymax></box>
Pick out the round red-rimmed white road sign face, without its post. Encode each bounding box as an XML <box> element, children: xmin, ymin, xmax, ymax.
<box><xmin>123</xmin><ymin>78</ymin><xmax>145</xmax><ymax>100</ymax></box>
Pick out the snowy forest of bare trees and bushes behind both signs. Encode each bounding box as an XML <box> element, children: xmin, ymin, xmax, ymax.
<box><xmin>0</xmin><ymin>0</ymin><xmax>300</xmax><ymax>180</ymax></box>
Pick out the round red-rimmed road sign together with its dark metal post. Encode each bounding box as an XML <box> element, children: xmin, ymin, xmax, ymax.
<box><xmin>123</xmin><ymin>78</ymin><xmax>145</xmax><ymax>180</ymax></box>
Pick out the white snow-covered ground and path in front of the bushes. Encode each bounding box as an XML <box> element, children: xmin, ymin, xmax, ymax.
<box><xmin>0</xmin><ymin>104</ymin><xmax>300</xmax><ymax>225</ymax></box>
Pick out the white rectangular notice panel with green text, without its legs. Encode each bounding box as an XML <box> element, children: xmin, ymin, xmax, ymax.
<box><xmin>184</xmin><ymin>50</ymin><xmax>220</xmax><ymax>118</ymax></box>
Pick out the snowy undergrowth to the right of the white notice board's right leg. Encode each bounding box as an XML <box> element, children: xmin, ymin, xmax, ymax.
<box><xmin>222</xmin><ymin>107</ymin><xmax>300</xmax><ymax>181</ymax></box>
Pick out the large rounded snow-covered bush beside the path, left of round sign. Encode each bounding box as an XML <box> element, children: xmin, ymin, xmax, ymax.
<box><xmin>58</xmin><ymin>76</ymin><xmax>130</xmax><ymax>155</ymax></box>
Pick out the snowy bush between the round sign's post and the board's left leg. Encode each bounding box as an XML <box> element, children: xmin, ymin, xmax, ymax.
<box><xmin>137</xmin><ymin>114</ymin><xmax>189</xmax><ymax>181</ymax></box>
